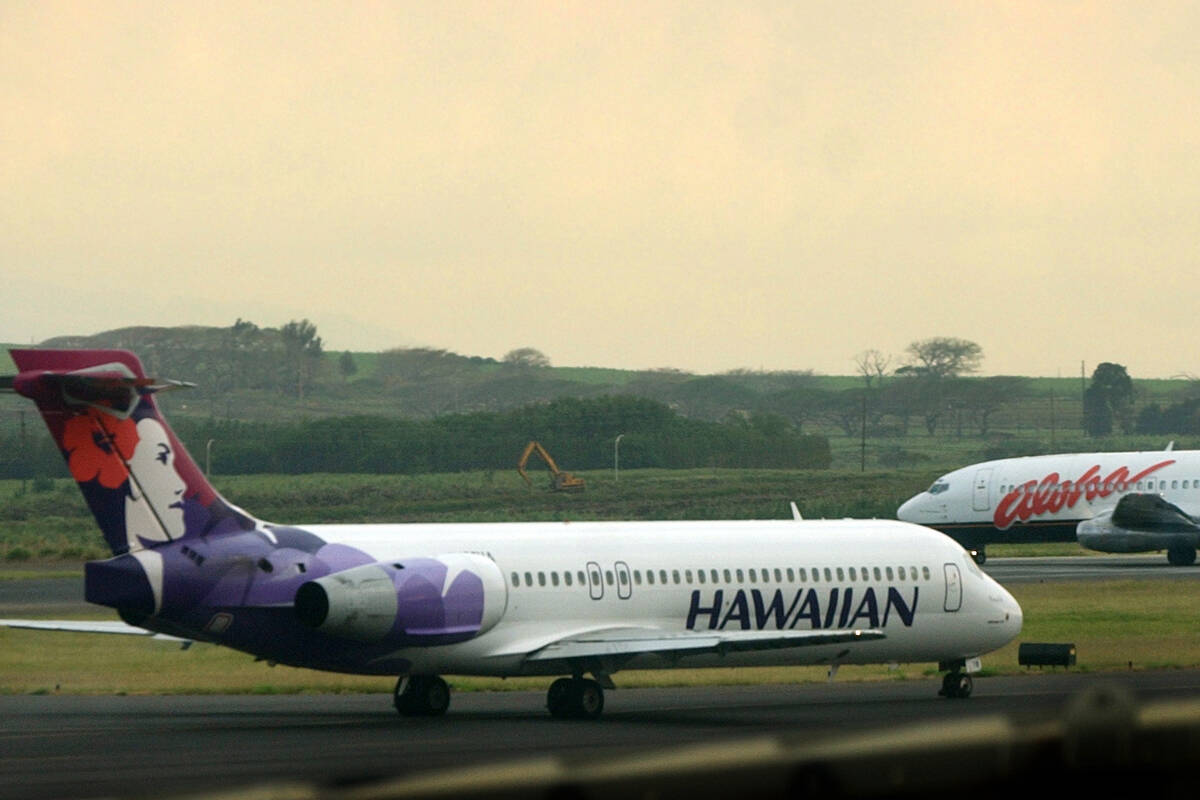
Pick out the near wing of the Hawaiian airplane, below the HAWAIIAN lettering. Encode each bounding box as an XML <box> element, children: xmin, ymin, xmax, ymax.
<box><xmin>526</xmin><ymin>628</ymin><xmax>886</xmax><ymax>661</ymax></box>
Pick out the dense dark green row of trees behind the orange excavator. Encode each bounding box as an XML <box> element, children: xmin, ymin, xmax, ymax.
<box><xmin>0</xmin><ymin>396</ymin><xmax>833</xmax><ymax>477</ymax></box>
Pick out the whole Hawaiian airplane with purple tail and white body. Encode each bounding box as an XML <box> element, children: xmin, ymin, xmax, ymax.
<box><xmin>2</xmin><ymin>350</ymin><xmax>1021</xmax><ymax>718</ymax></box>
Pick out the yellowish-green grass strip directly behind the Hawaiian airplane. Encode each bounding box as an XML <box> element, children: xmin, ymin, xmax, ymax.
<box><xmin>0</xmin><ymin>581</ymin><xmax>1200</xmax><ymax>694</ymax></box>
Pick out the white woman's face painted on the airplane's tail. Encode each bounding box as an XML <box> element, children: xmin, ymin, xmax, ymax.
<box><xmin>125</xmin><ymin>417</ymin><xmax>187</xmax><ymax>546</ymax></box>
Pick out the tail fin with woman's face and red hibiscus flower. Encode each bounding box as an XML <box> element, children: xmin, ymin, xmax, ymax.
<box><xmin>5</xmin><ymin>349</ymin><xmax>256</xmax><ymax>555</ymax></box>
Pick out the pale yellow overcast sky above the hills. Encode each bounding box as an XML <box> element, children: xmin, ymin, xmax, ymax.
<box><xmin>0</xmin><ymin>0</ymin><xmax>1200</xmax><ymax>378</ymax></box>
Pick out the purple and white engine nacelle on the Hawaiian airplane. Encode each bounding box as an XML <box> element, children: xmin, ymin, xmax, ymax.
<box><xmin>295</xmin><ymin>553</ymin><xmax>509</xmax><ymax>645</ymax></box>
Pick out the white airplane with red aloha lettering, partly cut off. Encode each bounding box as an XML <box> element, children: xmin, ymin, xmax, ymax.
<box><xmin>896</xmin><ymin>443</ymin><xmax>1200</xmax><ymax>566</ymax></box>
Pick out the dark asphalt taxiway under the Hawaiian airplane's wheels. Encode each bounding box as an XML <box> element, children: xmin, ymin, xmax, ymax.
<box><xmin>7</xmin><ymin>670</ymin><xmax>1200</xmax><ymax>799</ymax></box>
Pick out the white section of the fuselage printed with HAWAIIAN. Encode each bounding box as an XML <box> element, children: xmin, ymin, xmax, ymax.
<box><xmin>304</xmin><ymin>521</ymin><xmax>1021</xmax><ymax>675</ymax></box>
